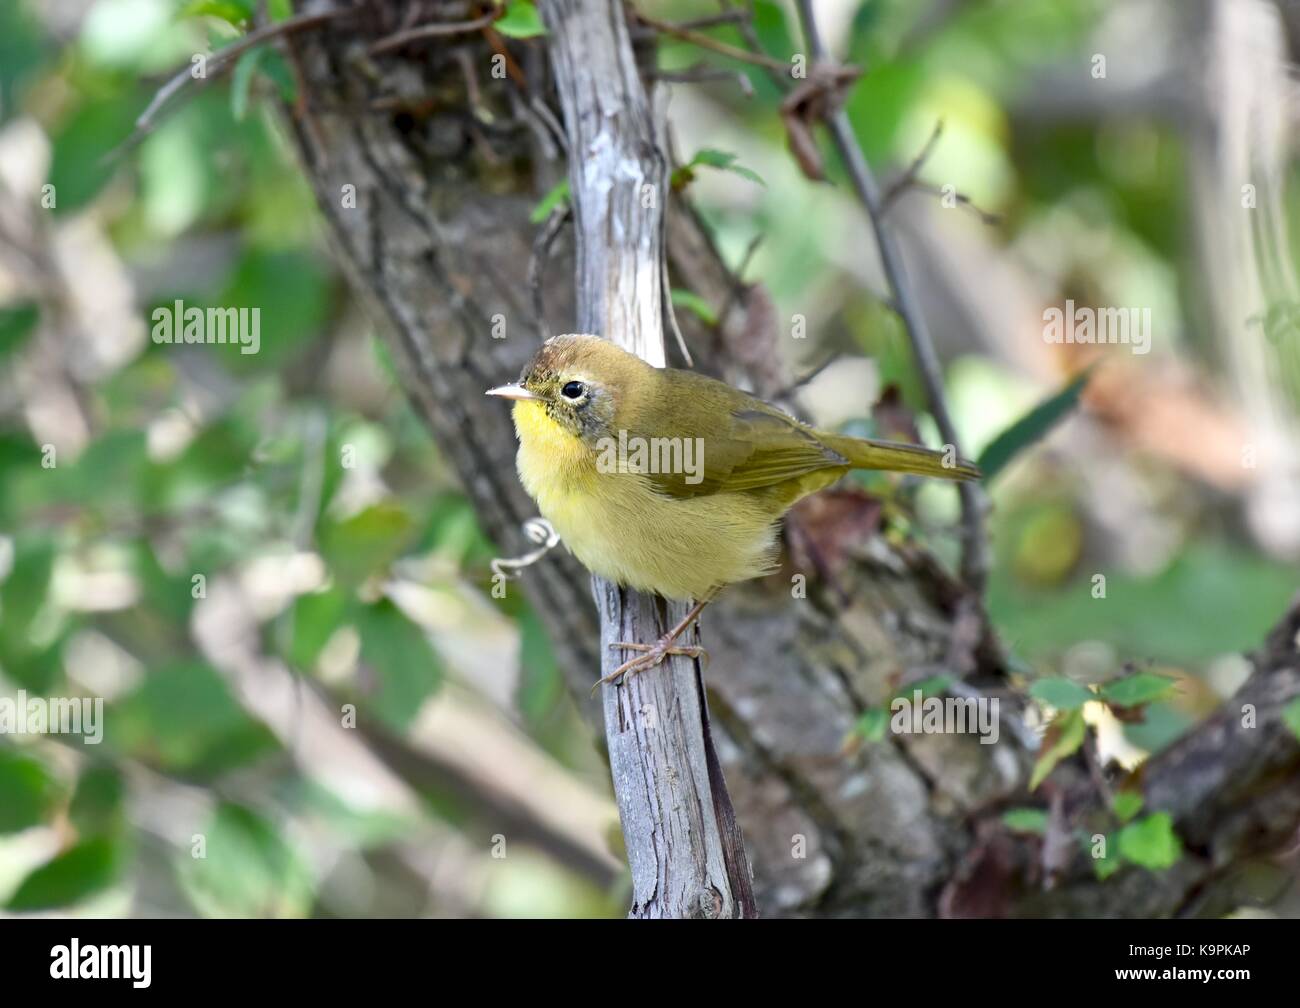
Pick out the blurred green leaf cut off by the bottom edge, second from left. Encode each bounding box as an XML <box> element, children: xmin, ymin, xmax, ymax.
<box><xmin>177</xmin><ymin>802</ymin><xmax>315</xmax><ymax>918</ymax></box>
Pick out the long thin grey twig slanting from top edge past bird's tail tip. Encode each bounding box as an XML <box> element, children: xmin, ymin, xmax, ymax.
<box><xmin>798</xmin><ymin>0</ymin><xmax>988</xmax><ymax>592</ymax></box>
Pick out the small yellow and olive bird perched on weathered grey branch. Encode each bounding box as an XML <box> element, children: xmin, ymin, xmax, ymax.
<box><xmin>488</xmin><ymin>334</ymin><xmax>979</xmax><ymax>685</ymax></box>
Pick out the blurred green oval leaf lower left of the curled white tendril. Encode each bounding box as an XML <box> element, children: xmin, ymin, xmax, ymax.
<box><xmin>358</xmin><ymin>598</ymin><xmax>442</xmax><ymax>731</ymax></box>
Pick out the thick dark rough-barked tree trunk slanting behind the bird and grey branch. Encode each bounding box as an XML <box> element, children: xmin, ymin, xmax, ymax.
<box><xmin>285</xmin><ymin>3</ymin><xmax>1300</xmax><ymax>916</ymax></box>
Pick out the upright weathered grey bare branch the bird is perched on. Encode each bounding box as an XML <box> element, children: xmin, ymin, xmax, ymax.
<box><xmin>541</xmin><ymin>0</ymin><xmax>758</xmax><ymax>917</ymax></box>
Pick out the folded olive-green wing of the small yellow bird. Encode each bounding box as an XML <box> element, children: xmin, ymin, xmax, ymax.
<box><xmin>620</xmin><ymin>371</ymin><xmax>849</xmax><ymax>498</ymax></box>
